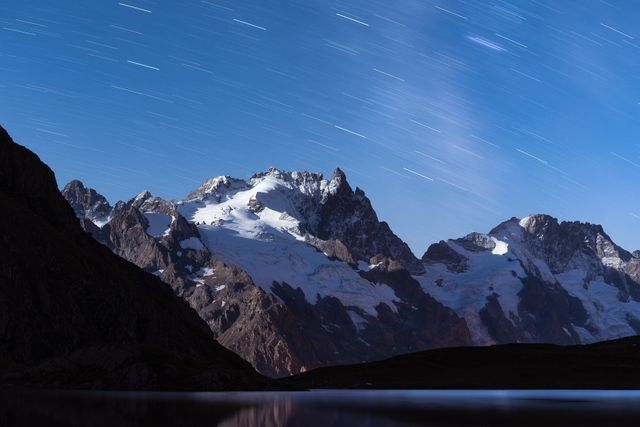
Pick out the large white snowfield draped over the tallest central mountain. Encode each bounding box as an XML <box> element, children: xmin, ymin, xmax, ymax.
<box><xmin>177</xmin><ymin>171</ymin><xmax>396</xmax><ymax>316</ymax></box>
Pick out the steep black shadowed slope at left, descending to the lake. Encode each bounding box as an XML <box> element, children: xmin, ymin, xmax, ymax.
<box><xmin>0</xmin><ymin>128</ymin><xmax>263</xmax><ymax>389</ymax></box>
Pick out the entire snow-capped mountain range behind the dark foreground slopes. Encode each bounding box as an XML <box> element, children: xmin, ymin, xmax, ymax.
<box><xmin>65</xmin><ymin>168</ymin><xmax>640</xmax><ymax>376</ymax></box>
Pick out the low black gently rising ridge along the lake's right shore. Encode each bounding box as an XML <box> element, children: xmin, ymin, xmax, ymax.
<box><xmin>280</xmin><ymin>337</ymin><xmax>640</xmax><ymax>390</ymax></box>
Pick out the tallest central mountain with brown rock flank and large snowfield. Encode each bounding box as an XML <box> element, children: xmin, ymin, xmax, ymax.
<box><xmin>67</xmin><ymin>169</ymin><xmax>471</xmax><ymax>376</ymax></box>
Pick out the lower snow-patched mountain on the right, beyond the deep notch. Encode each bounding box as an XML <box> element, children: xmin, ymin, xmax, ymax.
<box><xmin>416</xmin><ymin>215</ymin><xmax>640</xmax><ymax>345</ymax></box>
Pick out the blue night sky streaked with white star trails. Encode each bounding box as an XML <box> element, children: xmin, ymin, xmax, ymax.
<box><xmin>0</xmin><ymin>0</ymin><xmax>640</xmax><ymax>255</ymax></box>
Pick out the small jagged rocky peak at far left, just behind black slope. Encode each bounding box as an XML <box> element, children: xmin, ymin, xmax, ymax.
<box><xmin>62</xmin><ymin>179</ymin><xmax>113</xmax><ymax>227</ymax></box>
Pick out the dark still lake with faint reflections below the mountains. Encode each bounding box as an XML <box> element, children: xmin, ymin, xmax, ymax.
<box><xmin>0</xmin><ymin>390</ymin><xmax>640</xmax><ymax>427</ymax></box>
